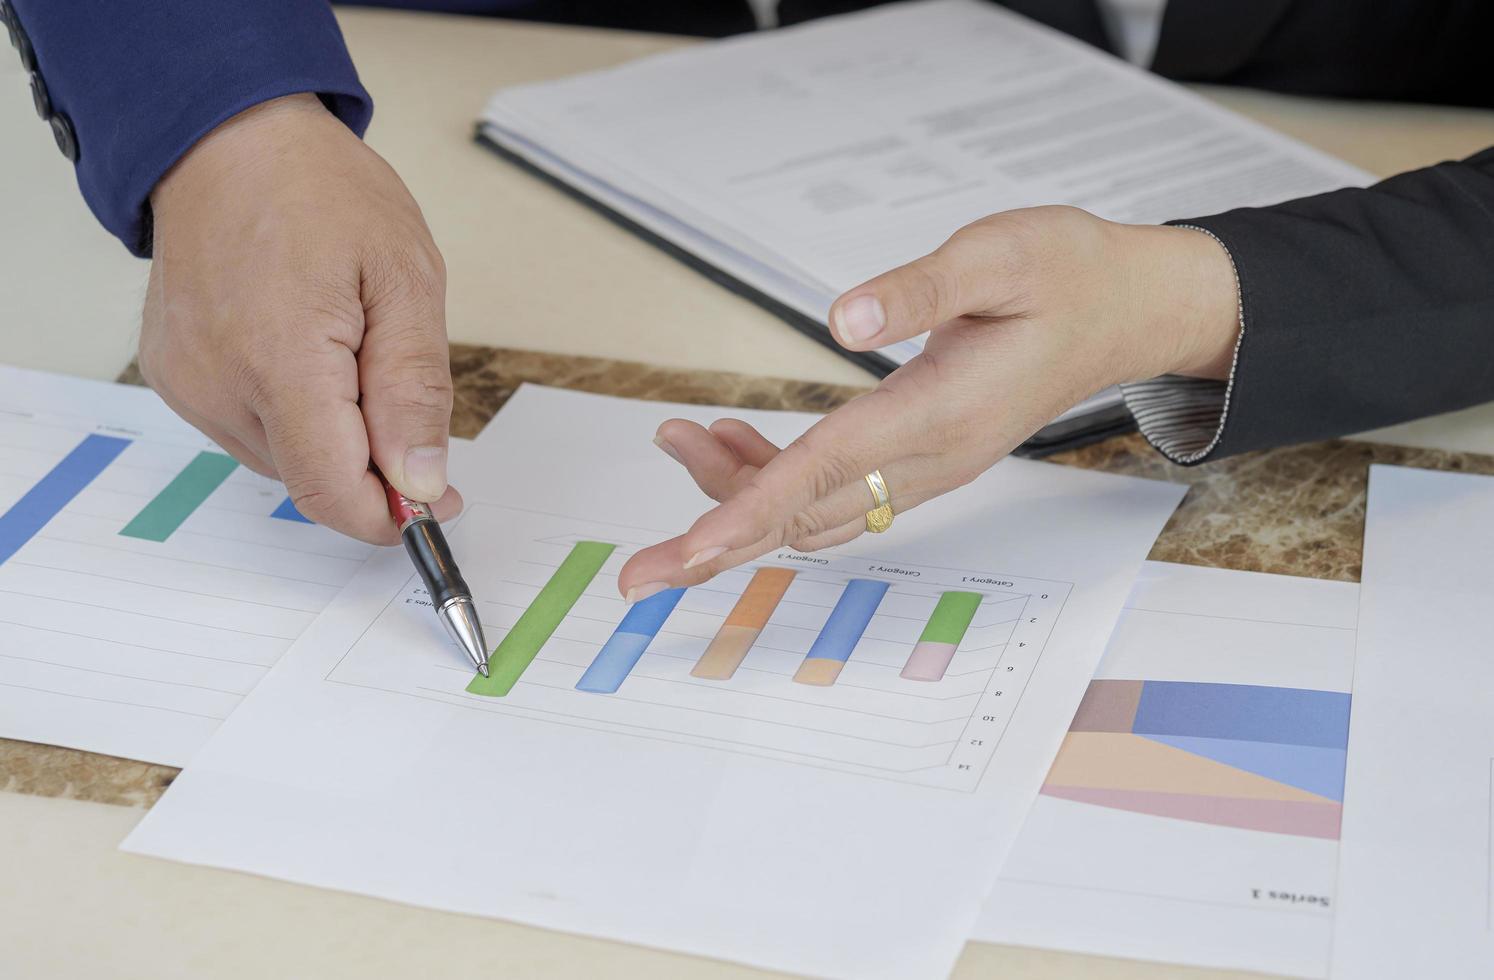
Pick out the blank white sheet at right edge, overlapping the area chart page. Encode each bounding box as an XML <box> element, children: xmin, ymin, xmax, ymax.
<box><xmin>1333</xmin><ymin>466</ymin><xmax>1494</xmax><ymax>980</ymax></box>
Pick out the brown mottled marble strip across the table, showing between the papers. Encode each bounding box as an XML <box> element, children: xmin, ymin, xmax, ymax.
<box><xmin>0</xmin><ymin>345</ymin><xmax>1494</xmax><ymax>807</ymax></box>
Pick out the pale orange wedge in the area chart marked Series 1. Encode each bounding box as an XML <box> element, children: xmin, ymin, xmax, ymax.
<box><xmin>1047</xmin><ymin>732</ymin><xmax>1336</xmax><ymax>804</ymax></box>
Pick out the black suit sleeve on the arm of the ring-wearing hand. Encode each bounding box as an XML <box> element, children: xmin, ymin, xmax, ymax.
<box><xmin>1128</xmin><ymin>149</ymin><xmax>1494</xmax><ymax>463</ymax></box>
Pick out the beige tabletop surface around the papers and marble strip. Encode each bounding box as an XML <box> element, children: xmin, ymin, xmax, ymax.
<box><xmin>0</xmin><ymin>10</ymin><xmax>1494</xmax><ymax>980</ymax></box>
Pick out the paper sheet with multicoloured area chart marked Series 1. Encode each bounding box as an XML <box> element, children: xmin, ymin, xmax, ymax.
<box><xmin>974</xmin><ymin>562</ymin><xmax>1358</xmax><ymax>977</ymax></box>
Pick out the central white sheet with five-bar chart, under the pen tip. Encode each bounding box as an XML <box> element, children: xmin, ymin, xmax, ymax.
<box><xmin>127</xmin><ymin>387</ymin><xmax>1180</xmax><ymax>977</ymax></box>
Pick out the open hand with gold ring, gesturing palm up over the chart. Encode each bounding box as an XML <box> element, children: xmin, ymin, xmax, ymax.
<box><xmin>619</xmin><ymin>208</ymin><xmax>1239</xmax><ymax>601</ymax></box>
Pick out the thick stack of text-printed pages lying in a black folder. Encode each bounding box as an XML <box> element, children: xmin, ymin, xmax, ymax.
<box><xmin>478</xmin><ymin>0</ymin><xmax>1370</xmax><ymax>442</ymax></box>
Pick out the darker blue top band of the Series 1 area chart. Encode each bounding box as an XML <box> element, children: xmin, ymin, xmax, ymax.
<box><xmin>1131</xmin><ymin>681</ymin><xmax>1349</xmax><ymax>748</ymax></box>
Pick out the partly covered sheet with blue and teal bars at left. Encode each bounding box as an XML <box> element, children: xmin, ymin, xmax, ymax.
<box><xmin>0</xmin><ymin>368</ymin><xmax>369</xmax><ymax>765</ymax></box>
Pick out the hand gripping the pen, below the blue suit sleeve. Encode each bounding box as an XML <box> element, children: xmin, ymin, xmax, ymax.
<box><xmin>140</xmin><ymin>94</ymin><xmax>462</xmax><ymax>544</ymax></box>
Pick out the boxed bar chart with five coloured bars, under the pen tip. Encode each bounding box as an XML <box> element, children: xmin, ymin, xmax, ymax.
<box><xmin>326</xmin><ymin>503</ymin><xmax>1070</xmax><ymax>790</ymax></box>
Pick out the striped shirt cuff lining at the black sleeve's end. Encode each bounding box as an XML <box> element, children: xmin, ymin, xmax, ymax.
<box><xmin>1121</xmin><ymin>224</ymin><xmax>1245</xmax><ymax>466</ymax></box>
